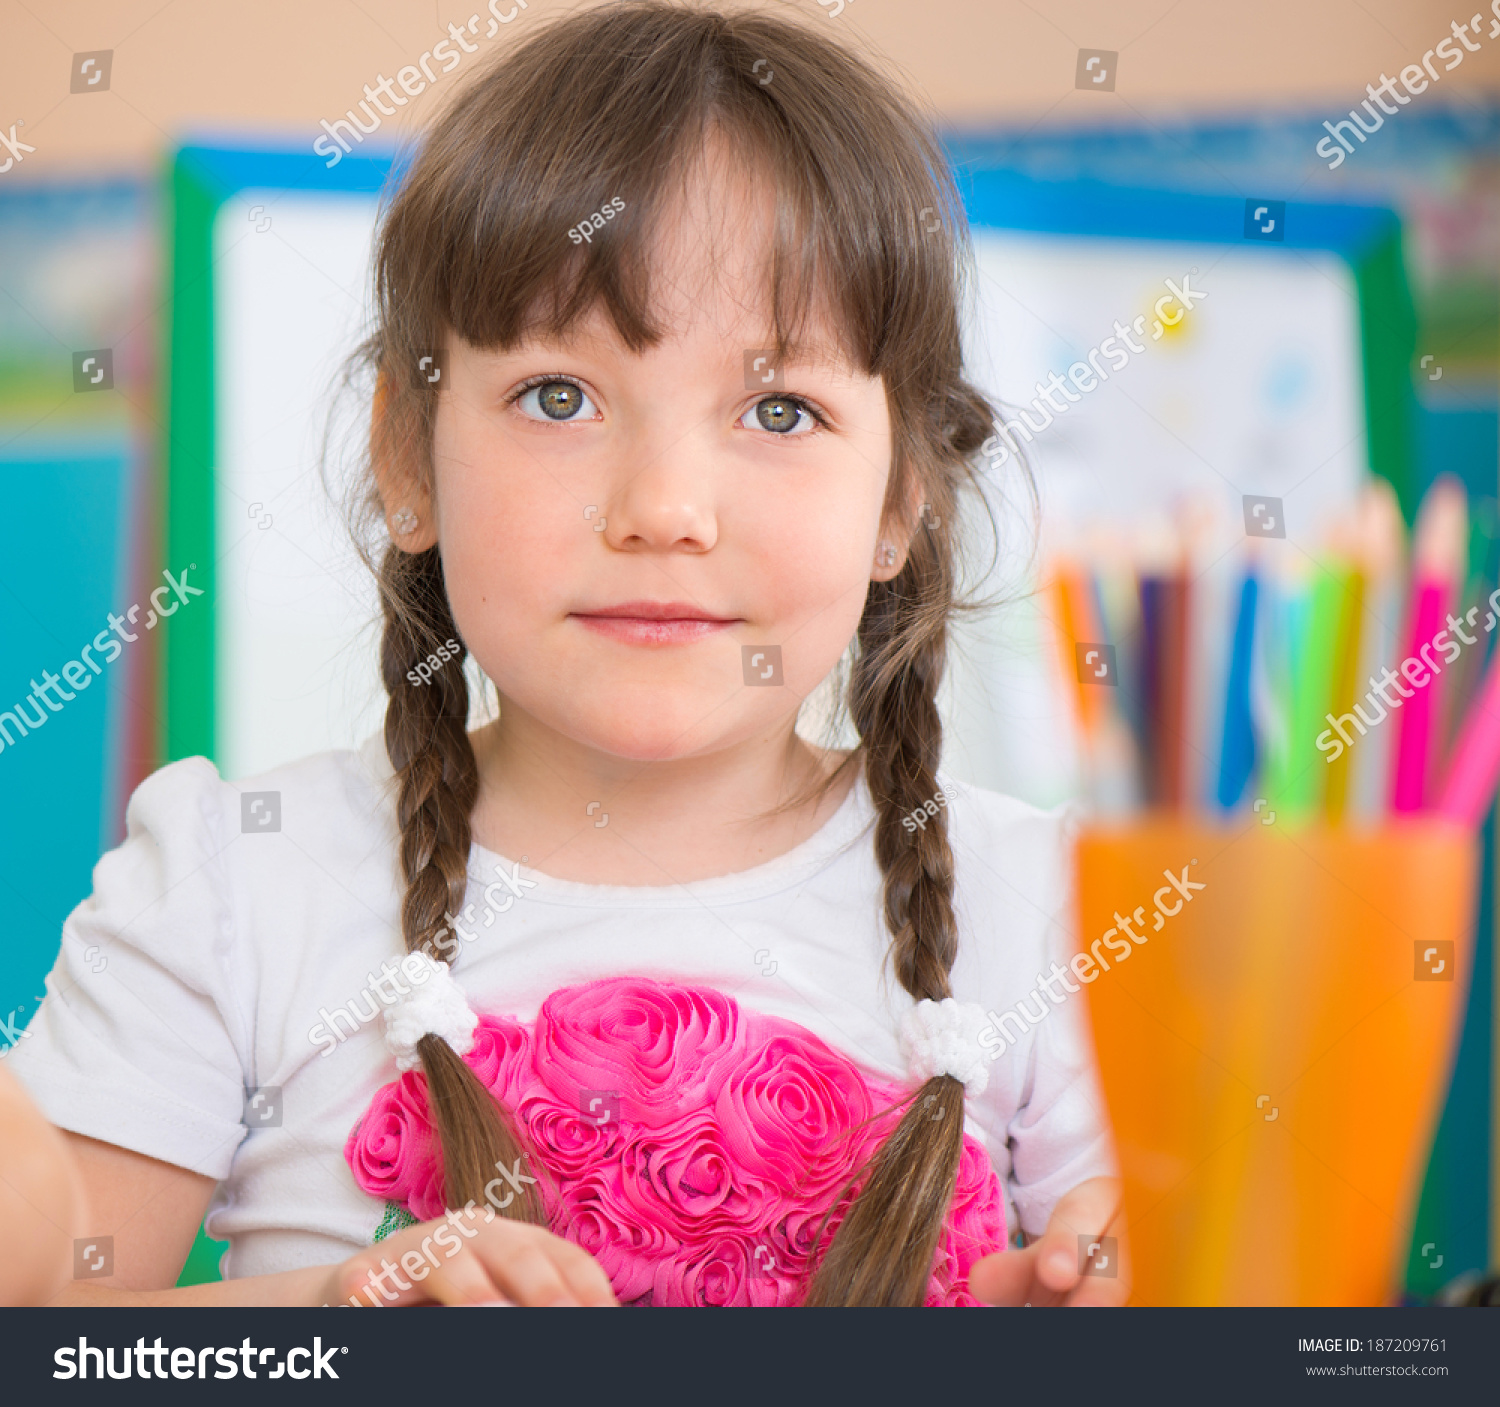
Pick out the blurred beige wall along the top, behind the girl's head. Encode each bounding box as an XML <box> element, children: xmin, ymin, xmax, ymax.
<box><xmin>0</xmin><ymin>0</ymin><xmax>1500</xmax><ymax>183</ymax></box>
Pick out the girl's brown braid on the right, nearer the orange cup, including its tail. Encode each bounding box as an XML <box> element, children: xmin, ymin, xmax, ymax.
<box><xmin>807</xmin><ymin>534</ymin><xmax>963</xmax><ymax>1305</ymax></box>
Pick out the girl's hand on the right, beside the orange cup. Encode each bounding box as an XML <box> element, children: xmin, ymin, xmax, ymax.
<box><xmin>969</xmin><ymin>1178</ymin><xmax>1130</xmax><ymax>1305</ymax></box>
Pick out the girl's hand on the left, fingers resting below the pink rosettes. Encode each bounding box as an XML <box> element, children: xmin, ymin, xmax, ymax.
<box><xmin>326</xmin><ymin>1202</ymin><xmax>618</xmax><ymax>1308</ymax></box>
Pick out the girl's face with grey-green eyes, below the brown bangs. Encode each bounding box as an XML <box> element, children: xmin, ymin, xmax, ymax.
<box><xmin>389</xmin><ymin>159</ymin><xmax>908</xmax><ymax>761</ymax></box>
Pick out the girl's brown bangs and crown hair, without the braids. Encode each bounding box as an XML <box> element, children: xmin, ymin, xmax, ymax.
<box><xmin>375</xmin><ymin>5</ymin><xmax>963</xmax><ymax>380</ymax></box>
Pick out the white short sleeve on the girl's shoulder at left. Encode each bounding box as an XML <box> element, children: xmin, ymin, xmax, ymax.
<box><xmin>9</xmin><ymin>758</ymin><xmax>254</xmax><ymax>1179</ymax></box>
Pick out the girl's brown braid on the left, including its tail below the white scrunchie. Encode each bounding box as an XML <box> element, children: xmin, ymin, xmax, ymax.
<box><xmin>380</xmin><ymin>548</ymin><xmax>546</xmax><ymax>1226</ymax></box>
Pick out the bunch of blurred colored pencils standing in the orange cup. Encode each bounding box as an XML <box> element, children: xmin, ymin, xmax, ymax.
<box><xmin>1046</xmin><ymin>476</ymin><xmax>1500</xmax><ymax>827</ymax></box>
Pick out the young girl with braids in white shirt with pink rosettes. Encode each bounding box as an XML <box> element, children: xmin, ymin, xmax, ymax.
<box><xmin>8</xmin><ymin>3</ymin><xmax>1125</xmax><ymax>1305</ymax></box>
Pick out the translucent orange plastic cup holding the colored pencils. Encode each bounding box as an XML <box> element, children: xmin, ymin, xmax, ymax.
<box><xmin>1074</xmin><ymin>819</ymin><xmax>1476</xmax><ymax>1305</ymax></box>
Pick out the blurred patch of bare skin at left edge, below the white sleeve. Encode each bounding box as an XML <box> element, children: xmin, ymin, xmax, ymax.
<box><xmin>0</xmin><ymin>1065</ymin><xmax>83</xmax><ymax>1305</ymax></box>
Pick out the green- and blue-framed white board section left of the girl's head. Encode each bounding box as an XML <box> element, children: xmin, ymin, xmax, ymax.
<box><xmin>162</xmin><ymin>147</ymin><xmax>390</xmax><ymax>777</ymax></box>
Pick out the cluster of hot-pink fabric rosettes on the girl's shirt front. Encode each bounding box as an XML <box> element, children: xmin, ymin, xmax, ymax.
<box><xmin>345</xmin><ymin>978</ymin><xmax>1005</xmax><ymax>1305</ymax></box>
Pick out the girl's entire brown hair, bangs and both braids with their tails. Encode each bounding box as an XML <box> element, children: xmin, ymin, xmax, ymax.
<box><xmin>349</xmin><ymin>0</ymin><xmax>993</xmax><ymax>1305</ymax></box>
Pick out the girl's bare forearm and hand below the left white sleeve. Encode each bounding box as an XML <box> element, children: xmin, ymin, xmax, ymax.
<box><xmin>51</xmin><ymin>1134</ymin><xmax>615</xmax><ymax>1307</ymax></box>
